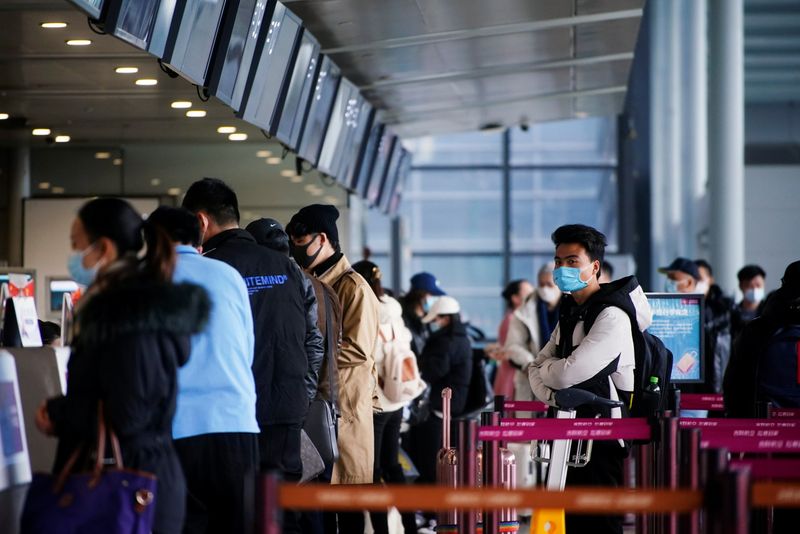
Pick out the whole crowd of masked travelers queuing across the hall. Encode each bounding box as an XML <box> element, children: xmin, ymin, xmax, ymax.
<box><xmin>26</xmin><ymin>178</ymin><xmax>800</xmax><ymax>534</ymax></box>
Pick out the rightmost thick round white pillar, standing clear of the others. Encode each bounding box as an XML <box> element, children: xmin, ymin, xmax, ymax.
<box><xmin>708</xmin><ymin>0</ymin><xmax>745</xmax><ymax>292</ymax></box>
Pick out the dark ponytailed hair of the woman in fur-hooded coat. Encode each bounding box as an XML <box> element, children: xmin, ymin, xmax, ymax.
<box><xmin>78</xmin><ymin>198</ymin><xmax>175</xmax><ymax>287</ymax></box>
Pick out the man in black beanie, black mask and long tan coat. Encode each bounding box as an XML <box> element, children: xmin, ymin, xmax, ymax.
<box><xmin>286</xmin><ymin>204</ymin><xmax>380</xmax><ymax>534</ymax></box>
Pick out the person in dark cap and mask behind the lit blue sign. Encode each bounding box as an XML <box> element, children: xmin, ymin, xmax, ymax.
<box><xmin>658</xmin><ymin>257</ymin><xmax>733</xmax><ymax>398</ymax></box>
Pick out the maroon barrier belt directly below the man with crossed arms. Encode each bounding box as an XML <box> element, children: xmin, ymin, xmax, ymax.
<box><xmin>478</xmin><ymin>418</ymin><xmax>652</xmax><ymax>442</ymax></box>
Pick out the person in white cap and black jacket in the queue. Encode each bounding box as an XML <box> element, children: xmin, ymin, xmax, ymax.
<box><xmin>411</xmin><ymin>295</ymin><xmax>472</xmax><ymax>490</ymax></box>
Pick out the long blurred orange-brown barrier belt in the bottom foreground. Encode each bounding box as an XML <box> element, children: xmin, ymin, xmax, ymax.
<box><xmin>278</xmin><ymin>484</ymin><xmax>703</xmax><ymax>515</ymax></box>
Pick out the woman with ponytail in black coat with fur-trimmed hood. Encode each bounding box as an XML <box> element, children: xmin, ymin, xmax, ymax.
<box><xmin>36</xmin><ymin>198</ymin><xmax>209</xmax><ymax>533</ymax></box>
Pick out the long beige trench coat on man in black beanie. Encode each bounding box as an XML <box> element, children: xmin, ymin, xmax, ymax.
<box><xmin>319</xmin><ymin>256</ymin><xmax>380</xmax><ymax>484</ymax></box>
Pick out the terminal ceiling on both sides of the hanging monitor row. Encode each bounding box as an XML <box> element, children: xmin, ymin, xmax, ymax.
<box><xmin>0</xmin><ymin>0</ymin><xmax>643</xmax><ymax>149</ymax></box>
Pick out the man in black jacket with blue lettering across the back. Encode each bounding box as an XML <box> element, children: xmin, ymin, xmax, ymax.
<box><xmin>183</xmin><ymin>178</ymin><xmax>323</xmax><ymax>532</ymax></box>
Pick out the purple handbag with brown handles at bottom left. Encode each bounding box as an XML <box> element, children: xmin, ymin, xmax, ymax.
<box><xmin>21</xmin><ymin>402</ymin><xmax>156</xmax><ymax>534</ymax></box>
